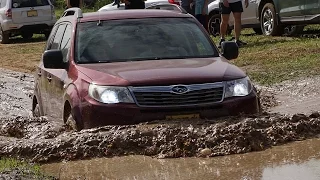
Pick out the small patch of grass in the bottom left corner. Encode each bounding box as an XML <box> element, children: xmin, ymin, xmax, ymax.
<box><xmin>0</xmin><ymin>158</ymin><xmax>56</xmax><ymax>180</ymax></box>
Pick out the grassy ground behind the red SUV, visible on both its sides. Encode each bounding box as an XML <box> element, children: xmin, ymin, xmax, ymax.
<box><xmin>0</xmin><ymin>16</ymin><xmax>320</xmax><ymax>85</ymax></box>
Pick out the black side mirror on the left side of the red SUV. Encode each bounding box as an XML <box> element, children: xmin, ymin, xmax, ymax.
<box><xmin>42</xmin><ymin>49</ymin><xmax>66</xmax><ymax>69</ymax></box>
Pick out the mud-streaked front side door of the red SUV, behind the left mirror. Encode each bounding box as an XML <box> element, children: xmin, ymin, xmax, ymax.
<box><xmin>50</xmin><ymin>24</ymin><xmax>72</xmax><ymax>119</ymax></box>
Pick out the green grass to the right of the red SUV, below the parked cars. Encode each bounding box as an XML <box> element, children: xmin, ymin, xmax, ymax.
<box><xmin>213</xmin><ymin>25</ymin><xmax>320</xmax><ymax>85</ymax></box>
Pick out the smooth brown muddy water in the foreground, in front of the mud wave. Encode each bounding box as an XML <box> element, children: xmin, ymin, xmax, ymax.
<box><xmin>42</xmin><ymin>139</ymin><xmax>320</xmax><ymax>180</ymax></box>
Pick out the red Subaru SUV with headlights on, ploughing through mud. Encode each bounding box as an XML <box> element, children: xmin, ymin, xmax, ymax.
<box><xmin>32</xmin><ymin>8</ymin><xmax>259</xmax><ymax>130</ymax></box>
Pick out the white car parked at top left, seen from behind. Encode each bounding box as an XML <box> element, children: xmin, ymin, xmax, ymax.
<box><xmin>0</xmin><ymin>0</ymin><xmax>56</xmax><ymax>44</ymax></box>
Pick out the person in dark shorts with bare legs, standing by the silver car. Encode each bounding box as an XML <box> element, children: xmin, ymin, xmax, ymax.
<box><xmin>219</xmin><ymin>0</ymin><xmax>249</xmax><ymax>47</ymax></box>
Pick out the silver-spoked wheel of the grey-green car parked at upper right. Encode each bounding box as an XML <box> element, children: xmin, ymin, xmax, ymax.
<box><xmin>260</xmin><ymin>3</ymin><xmax>284</xmax><ymax>36</ymax></box>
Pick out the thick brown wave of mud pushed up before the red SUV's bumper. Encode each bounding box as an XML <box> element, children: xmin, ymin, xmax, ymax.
<box><xmin>0</xmin><ymin>113</ymin><xmax>320</xmax><ymax>163</ymax></box>
